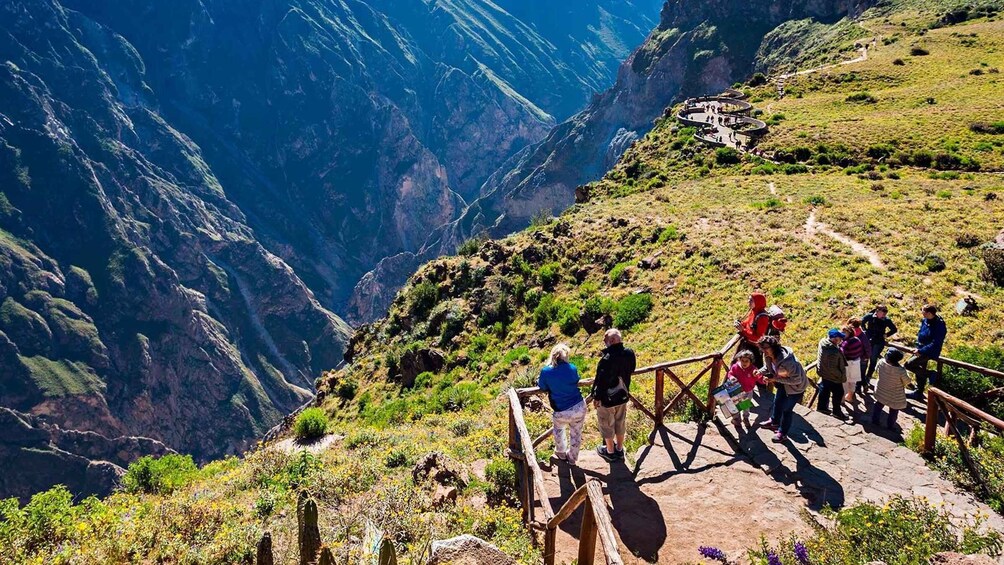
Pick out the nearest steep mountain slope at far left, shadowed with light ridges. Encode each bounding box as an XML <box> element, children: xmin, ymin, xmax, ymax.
<box><xmin>0</xmin><ymin>1</ymin><xmax>349</xmax><ymax>496</ymax></box>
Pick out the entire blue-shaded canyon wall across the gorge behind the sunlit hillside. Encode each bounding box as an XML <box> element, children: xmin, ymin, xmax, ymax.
<box><xmin>0</xmin><ymin>0</ymin><xmax>660</xmax><ymax>494</ymax></box>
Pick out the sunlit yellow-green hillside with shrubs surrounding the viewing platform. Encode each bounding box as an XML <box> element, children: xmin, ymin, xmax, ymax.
<box><xmin>0</xmin><ymin>0</ymin><xmax>1004</xmax><ymax>563</ymax></box>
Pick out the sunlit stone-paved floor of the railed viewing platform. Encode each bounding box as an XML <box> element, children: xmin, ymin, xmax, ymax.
<box><xmin>544</xmin><ymin>391</ymin><xmax>1004</xmax><ymax>563</ymax></box>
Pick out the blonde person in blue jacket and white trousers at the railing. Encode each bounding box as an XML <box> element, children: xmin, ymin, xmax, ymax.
<box><xmin>537</xmin><ymin>343</ymin><xmax>585</xmax><ymax>465</ymax></box>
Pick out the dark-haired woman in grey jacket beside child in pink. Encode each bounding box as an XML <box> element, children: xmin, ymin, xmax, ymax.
<box><xmin>758</xmin><ymin>335</ymin><xmax>809</xmax><ymax>444</ymax></box>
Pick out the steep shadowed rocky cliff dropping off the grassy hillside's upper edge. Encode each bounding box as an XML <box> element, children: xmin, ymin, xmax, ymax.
<box><xmin>350</xmin><ymin>0</ymin><xmax>869</xmax><ymax>317</ymax></box>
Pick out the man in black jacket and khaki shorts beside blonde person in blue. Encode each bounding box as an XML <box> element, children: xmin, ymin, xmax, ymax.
<box><xmin>592</xmin><ymin>328</ymin><xmax>637</xmax><ymax>462</ymax></box>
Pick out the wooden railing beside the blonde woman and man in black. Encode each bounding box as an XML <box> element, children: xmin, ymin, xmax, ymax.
<box><xmin>508</xmin><ymin>335</ymin><xmax>740</xmax><ymax>565</ymax></box>
